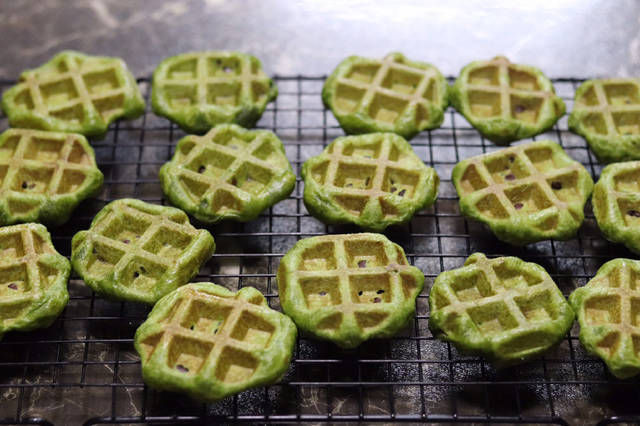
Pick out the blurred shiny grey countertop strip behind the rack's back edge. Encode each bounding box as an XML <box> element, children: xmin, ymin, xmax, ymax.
<box><xmin>0</xmin><ymin>0</ymin><xmax>640</xmax><ymax>78</ymax></box>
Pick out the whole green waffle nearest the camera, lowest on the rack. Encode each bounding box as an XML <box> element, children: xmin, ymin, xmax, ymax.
<box><xmin>134</xmin><ymin>283</ymin><xmax>297</xmax><ymax>401</ymax></box>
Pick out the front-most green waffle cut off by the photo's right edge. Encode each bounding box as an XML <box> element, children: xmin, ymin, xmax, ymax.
<box><xmin>569</xmin><ymin>259</ymin><xmax>640</xmax><ymax>379</ymax></box>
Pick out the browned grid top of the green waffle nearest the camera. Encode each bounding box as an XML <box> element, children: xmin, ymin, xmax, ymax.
<box><xmin>140</xmin><ymin>286</ymin><xmax>292</xmax><ymax>400</ymax></box>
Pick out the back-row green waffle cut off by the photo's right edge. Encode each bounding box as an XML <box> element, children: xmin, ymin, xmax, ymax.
<box><xmin>569</xmin><ymin>78</ymin><xmax>640</xmax><ymax>163</ymax></box>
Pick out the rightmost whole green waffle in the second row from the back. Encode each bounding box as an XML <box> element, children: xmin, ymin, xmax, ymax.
<box><xmin>453</xmin><ymin>141</ymin><xmax>593</xmax><ymax>245</ymax></box>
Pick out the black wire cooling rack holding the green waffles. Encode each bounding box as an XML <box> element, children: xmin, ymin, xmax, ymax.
<box><xmin>0</xmin><ymin>76</ymin><xmax>640</xmax><ymax>425</ymax></box>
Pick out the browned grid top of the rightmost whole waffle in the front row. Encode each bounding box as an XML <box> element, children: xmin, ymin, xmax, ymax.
<box><xmin>431</xmin><ymin>254</ymin><xmax>567</xmax><ymax>360</ymax></box>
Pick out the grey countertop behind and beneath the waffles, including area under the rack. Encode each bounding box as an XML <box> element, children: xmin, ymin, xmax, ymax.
<box><xmin>0</xmin><ymin>0</ymin><xmax>640</xmax><ymax>424</ymax></box>
